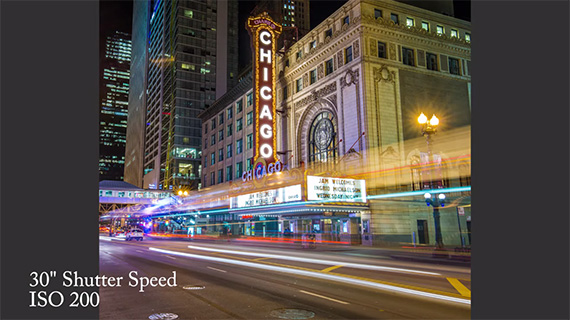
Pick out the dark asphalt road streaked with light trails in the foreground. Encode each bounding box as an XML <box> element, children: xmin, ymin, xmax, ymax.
<box><xmin>99</xmin><ymin>237</ymin><xmax>471</xmax><ymax>319</ymax></box>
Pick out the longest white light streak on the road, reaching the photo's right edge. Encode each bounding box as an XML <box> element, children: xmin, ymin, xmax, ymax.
<box><xmin>148</xmin><ymin>247</ymin><xmax>471</xmax><ymax>305</ymax></box>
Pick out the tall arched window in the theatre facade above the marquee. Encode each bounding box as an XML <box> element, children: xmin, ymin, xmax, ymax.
<box><xmin>308</xmin><ymin>111</ymin><xmax>338</xmax><ymax>162</ymax></box>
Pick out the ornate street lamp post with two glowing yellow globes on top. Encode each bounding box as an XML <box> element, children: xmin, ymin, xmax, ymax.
<box><xmin>418</xmin><ymin>112</ymin><xmax>445</xmax><ymax>249</ymax></box>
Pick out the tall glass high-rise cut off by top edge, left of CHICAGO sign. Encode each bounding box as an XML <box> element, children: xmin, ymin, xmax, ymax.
<box><xmin>125</xmin><ymin>0</ymin><xmax>237</xmax><ymax>189</ymax></box>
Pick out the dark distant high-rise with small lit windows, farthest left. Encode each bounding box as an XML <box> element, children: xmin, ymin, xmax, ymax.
<box><xmin>99</xmin><ymin>31</ymin><xmax>131</xmax><ymax>180</ymax></box>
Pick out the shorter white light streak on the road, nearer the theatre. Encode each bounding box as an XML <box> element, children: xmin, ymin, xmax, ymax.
<box><xmin>188</xmin><ymin>246</ymin><xmax>440</xmax><ymax>276</ymax></box>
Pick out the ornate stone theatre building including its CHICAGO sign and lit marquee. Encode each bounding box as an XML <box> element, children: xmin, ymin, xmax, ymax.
<box><xmin>200</xmin><ymin>0</ymin><xmax>471</xmax><ymax>244</ymax></box>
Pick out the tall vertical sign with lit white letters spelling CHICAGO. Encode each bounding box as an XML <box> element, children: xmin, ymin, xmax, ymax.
<box><xmin>244</xmin><ymin>13</ymin><xmax>281</xmax><ymax>180</ymax></box>
